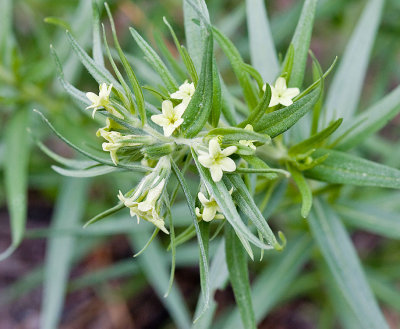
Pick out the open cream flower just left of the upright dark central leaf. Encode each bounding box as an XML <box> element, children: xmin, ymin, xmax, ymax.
<box><xmin>151</xmin><ymin>100</ymin><xmax>187</xmax><ymax>137</ymax></box>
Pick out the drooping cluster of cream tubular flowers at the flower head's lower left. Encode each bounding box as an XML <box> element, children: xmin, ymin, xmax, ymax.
<box><xmin>118</xmin><ymin>177</ymin><xmax>169</xmax><ymax>234</ymax></box>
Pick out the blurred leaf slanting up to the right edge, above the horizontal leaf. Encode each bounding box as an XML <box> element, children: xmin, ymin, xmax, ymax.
<box><xmin>336</xmin><ymin>86</ymin><xmax>400</xmax><ymax>151</ymax></box>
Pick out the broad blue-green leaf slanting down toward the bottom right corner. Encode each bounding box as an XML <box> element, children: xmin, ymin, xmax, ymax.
<box><xmin>308</xmin><ymin>200</ymin><xmax>389</xmax><ymax>329</ymax></box>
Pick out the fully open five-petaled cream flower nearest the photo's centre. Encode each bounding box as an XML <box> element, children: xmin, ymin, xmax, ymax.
<box><xmin>199</xmin><ymin>138</ymin><xmax>237</xmax><ymax>182</ymax></box>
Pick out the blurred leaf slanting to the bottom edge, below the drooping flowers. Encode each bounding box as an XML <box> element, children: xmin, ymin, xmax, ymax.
<box><xmin>130</xmin><ymin>230</ymin><xmax>191</xmax><ymax>329</ymax></box>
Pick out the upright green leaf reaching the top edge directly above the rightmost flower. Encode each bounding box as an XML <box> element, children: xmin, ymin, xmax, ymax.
<box><xmin>289</xmin><ymin>0</ymin><xmax>318</xmax><ymax>88</ymax></box>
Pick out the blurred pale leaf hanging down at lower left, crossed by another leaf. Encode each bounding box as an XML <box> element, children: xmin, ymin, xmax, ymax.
<box><xmin>40</xmin><ymin>178</ymin><xmax>88</xmax><ymax>329</ymax></box>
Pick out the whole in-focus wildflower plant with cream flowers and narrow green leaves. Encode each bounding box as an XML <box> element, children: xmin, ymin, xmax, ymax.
<box><xmin>32</xmin><ymin>0</ymin><xmax>400</xmax><ymax>328</ymax></box>
